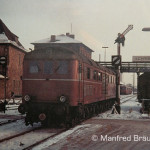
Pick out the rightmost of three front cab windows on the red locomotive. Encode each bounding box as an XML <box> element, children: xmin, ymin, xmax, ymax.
<box><xmin>55</xmin><ymin>61</ymin><xmax>68</xmax><ymax>74</ymax></box>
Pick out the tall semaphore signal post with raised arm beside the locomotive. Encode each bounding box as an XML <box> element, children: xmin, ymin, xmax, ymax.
<box><xmin>114</xmin><ymin>25</ymin><xmax>133</xmax><ymax>113</ymax></box>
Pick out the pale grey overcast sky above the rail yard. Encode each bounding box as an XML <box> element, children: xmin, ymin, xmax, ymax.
<box><xmin>0</xmin><ymin>0</ymin><xmax>150</xmax><ymax>84</ymax></box>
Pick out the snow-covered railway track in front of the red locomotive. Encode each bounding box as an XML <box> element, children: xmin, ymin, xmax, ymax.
<box><xmin>0</xmin><ymin>123</ymin><xmax>67</xmax><ymax>150</ymax></box>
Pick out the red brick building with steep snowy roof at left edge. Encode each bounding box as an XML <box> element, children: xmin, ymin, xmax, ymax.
<box><xmin>0</xmin><ymin>19</ymin><xmax>26</xmax><ymax>99</ymax></box>
